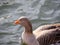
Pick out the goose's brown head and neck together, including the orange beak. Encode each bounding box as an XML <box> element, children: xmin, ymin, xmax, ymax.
<box><xmin>14</xmin><ymin>16</ymin><xmax>32</xmax><ymax>33</ymax></box>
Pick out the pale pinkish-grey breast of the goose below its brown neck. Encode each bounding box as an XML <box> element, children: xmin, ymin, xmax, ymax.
<box><xmin>22</xmin><ymin>32</ymin><xmax>39</xmax><ymax>45</ymax></box>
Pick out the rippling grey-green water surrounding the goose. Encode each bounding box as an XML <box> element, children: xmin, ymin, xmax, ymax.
<box><xmin>0</xmin><ymin>0</ymin><xmax>60</xmax><ymax>45</ymax></box>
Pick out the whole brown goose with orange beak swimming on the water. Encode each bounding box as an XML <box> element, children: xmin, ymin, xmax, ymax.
<box><xmin>14</xmin><ymin>16</ymin><xmax>60</xmax><ymax>45</ymax></box>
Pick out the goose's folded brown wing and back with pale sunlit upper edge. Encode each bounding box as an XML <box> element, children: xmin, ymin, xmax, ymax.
<box><xmin>33</xmin><ymin>23</ymin><xmax>60</xmax><ymax>45</ymax></box>
